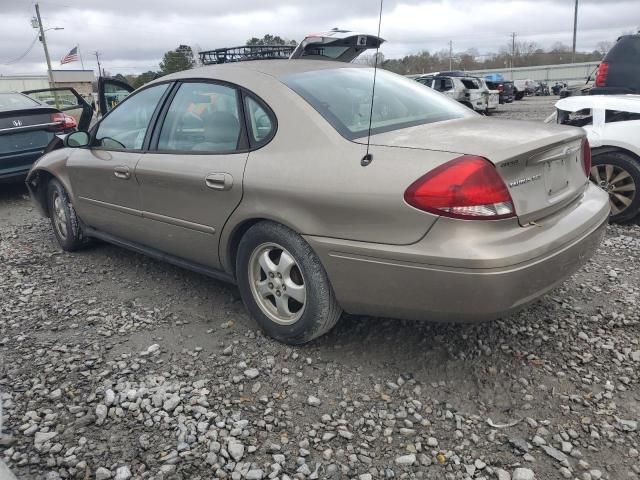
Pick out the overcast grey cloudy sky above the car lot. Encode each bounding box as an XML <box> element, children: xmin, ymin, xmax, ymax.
<box><xmin>0</xmin><ymin>0</ymin><xmax>640</xmax><ymax>75</ymax></box>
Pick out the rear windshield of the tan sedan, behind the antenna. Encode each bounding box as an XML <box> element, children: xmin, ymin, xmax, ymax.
<box><xmin>284</xmin><ymin>68</ymin><xmax>474</xmax><ymax>140</ymax></box>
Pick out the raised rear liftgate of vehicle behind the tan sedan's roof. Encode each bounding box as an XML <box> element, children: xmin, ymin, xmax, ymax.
<box><xmin>289</xmin><ymin>28</ymin><xmax>384</xmax><ymax>63</ymax></box>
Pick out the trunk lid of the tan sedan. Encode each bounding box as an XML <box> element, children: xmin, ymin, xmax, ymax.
<box><xmin>359</xmin><ymin>117</ymin><xmax>588</xmax><ymax>225</ymax></box>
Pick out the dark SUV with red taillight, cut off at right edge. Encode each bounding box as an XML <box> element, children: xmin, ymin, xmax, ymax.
<box><xmin>590</xmin><ymin>34</ymin><xmax>640</xmax><ymax>95</ymax></box>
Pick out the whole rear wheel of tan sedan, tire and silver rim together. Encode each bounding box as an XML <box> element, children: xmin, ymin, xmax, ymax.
<box><xmin>236</xmin><ymin>222</ymin><xmax>342</xmax><ymax>345</ymax></box>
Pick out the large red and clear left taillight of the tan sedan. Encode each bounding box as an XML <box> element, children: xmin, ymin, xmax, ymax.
<box><xmin>404</xmin><ymin>155</ymin><xmax>515</xmax><ymax>220</ymax></box>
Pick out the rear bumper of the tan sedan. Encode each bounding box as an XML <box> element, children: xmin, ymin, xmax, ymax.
<box><xmin>307</xmin><ymin>186</ymin><xmax>609</xmax><ymax>322</ymax></box>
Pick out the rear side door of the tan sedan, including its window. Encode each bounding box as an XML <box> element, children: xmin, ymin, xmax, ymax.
<box><xmin>136</xmin><ymin>81</ymin><xmax>256</xmax><ymax>268</ymax></box>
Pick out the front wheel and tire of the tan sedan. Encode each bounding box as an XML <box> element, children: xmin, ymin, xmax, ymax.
<box><xmin>47</xmin><ymin>179</ymin><xmax>88</xmax><ymax>252</ymax></box>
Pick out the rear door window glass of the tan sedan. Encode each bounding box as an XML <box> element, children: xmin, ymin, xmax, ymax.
<box><xmin>158</xmin><ymin>82</ymin><xmax>240</xmax><ymax>153</ymax></box>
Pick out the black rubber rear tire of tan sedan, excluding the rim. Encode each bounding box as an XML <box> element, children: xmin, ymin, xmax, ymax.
<box><xmin>236</xmin><ymin>222</ymin><xmax>336</xmax><ymax>345</ymax></box>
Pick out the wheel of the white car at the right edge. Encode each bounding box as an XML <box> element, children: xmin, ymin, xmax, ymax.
<box><xmin>589</xmin><ymin>151</ymin><xmax>640</xmax><ymax>223</ymax></box>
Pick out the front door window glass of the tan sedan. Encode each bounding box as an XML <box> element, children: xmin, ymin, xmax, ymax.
<box><xmin>94</xmin><ymin>83</ymin><xmax>168</xmax><ymax>150</ymax></box>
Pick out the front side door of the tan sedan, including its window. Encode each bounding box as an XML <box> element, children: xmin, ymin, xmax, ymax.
<box><xmin>67</xmin><ymin>83</ymin><xmax>170</xmax><ymax>241</ymax></box>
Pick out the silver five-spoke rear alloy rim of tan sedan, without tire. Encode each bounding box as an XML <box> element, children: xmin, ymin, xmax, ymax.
<box><xmin>249</xmin><ymin>243</ymin><xmax>307</xmax><ymax>325</ymax></box>
